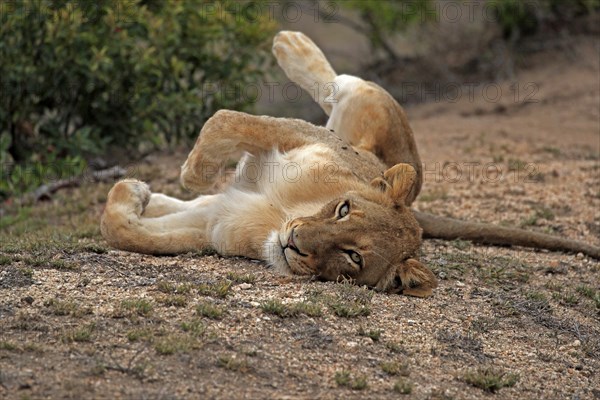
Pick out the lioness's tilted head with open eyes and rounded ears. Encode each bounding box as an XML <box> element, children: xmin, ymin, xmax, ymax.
<box><xmin>269</xmin><ymin>164</ymin><xmax>437</xmax><ymax>297</ymax></box>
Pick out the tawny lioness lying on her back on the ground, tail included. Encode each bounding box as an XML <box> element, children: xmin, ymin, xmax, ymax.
<box><xmin>101</xmin><ymin>31</ymin><xmax>600</xmax><ymax>297</ymax></box>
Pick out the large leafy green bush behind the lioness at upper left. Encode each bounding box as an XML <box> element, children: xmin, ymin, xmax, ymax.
<box><xmin>0</xmin><ymin>0</ymin><xmax>274</xmax><ymax>197</ymax></box>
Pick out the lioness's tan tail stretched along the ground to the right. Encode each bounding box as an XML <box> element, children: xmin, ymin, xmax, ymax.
<box><xmin>414</xmin><ymin>211</ymin><xmax>600</xmax><ymax>259</ymax></box>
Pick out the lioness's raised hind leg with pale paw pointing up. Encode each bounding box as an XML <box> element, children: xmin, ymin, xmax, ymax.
<box><xmin>273</xmin><ymin>31</ymin><xmax>423</xmax><ymax>204</ymax></box>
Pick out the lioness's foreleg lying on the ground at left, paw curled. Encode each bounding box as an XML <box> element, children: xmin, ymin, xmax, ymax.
<box><xmin>100</xmin><ymin>180</ymin><xmax>209</xmax><ymax>254</ymax></box>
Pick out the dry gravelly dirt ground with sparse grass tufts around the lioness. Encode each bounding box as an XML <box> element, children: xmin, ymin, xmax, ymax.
<box><xmin>0</xmin><ymin>41</ymin><xmax>600</xmax><ymax>399</ymax></box>
